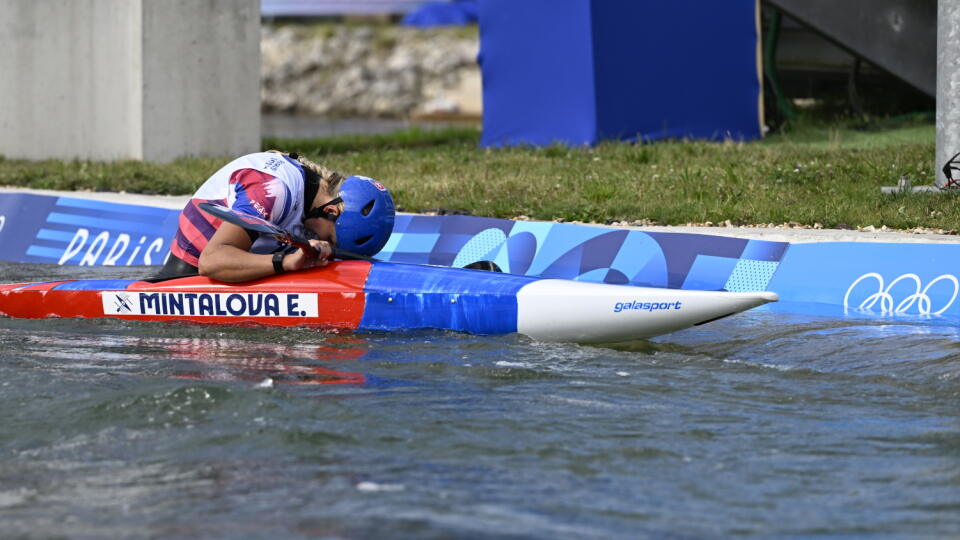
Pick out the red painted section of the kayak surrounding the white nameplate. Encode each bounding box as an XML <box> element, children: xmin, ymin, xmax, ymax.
<box><xmin>0</xmin><ymin>261</ymin><xmax>371</xmax><ymax>330</ymax></box>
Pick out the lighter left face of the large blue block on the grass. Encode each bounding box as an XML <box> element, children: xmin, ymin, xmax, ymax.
<box><xmin>479</xmin><ymin>0</ymin><xmax>597</xmax><ymax>146</ymax></box>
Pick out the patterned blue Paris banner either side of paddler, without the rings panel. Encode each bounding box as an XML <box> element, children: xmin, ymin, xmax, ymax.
<box><xmin>0</xmin><ymin>193</ymin><xmax>787</xmax><ymax>291</ymax></box>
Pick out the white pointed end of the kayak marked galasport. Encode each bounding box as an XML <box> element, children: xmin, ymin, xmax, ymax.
<box><xmin>517</xmin><ymin>279</ymin><xmax>778</xmax><ymax>343</ymax></box>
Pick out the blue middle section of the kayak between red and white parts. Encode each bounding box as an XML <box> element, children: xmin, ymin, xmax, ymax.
<box><xmin>360</xmin><ymin>263</ymin><xmax>538</xmax><ymax>334</ymax></box>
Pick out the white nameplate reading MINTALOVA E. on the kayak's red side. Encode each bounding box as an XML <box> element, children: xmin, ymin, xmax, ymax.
<box><xmin>101</xmin><ymin>291</ymin><xmax>317</xmax><ymax>317</ymax></box>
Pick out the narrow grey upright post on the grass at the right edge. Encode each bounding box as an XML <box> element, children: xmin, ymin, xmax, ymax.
<box><xmin>935</xmin><ymin>0</ymin><xmax>960</xmax><ymax>187</ymax></box>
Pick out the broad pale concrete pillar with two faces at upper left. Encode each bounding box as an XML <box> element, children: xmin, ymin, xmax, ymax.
<box><xmin>0</xmin><ymin>0</ymin><xmax>260</xmax><ymax>162</ymax></box>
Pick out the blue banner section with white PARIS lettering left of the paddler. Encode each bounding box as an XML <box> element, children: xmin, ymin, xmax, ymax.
<box><xmin>0</xmin><ymin>193</ymin><xmax>180</xmax><ymax>266</ymax></box>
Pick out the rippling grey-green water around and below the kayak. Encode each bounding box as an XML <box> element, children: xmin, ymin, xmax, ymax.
<box><xmin>0</xmin><ymin>264</ymin><xmax>960</xmax><ymax>538</ymax></box>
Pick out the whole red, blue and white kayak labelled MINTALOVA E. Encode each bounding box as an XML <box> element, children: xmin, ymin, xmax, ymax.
<box><xmin>0</xmin><ymin>261</ymin><xmax>777</xmax><ymax>343</ymax></box>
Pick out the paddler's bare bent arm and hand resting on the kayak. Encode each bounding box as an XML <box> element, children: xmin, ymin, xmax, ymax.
<box><xmin>198</xmin><ymin>223</ymin><xmax>333</xmax><ymax>282</ymax></box>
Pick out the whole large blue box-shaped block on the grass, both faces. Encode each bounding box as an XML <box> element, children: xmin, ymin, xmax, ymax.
<box><xmin>480</xmin><ymin>0</ymin><xmax>762</xmax><ymax>146</ymax></box>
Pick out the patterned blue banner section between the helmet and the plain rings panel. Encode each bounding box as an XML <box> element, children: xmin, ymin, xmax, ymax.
<box><xmin>377</xmin><ymin>215</ymin><xmax>788</xmax><ymax>292</ymax></box>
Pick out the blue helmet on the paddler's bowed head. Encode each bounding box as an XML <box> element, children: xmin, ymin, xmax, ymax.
<box><xmin>337</xmin><ymin>176</ymin><xmax>396</xmax><ymax>256</ymax></box>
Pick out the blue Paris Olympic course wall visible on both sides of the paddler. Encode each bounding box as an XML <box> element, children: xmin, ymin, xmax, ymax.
<box><xmin>0</xmin><ymin>192</ymin><xmax>960</xmax><ymax>318</ymax></box>
